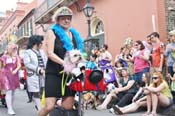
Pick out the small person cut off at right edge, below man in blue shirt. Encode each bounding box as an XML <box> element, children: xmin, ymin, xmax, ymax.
<box><xmin>168</xmin><ymin>63</ymin><xmax>175</xmax><ymax>103</ymax></box>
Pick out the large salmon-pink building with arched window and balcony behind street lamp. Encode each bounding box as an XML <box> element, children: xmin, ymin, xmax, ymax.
<box><xmin>35</xmin><ymin>0</ymin><xmax>167</xmax><ymax>56</ymax></box>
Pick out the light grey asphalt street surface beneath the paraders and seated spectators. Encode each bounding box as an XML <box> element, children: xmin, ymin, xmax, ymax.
<box><xmin>0</xmin><ymin>90</ymin><xmax>162</xmax><ymax>116</ymax></box>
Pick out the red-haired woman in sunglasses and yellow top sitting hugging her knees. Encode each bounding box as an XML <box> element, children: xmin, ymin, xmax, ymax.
<box><xmin>143</xmin><ymin>72</ymin><xmax>173</xmax><ymax>116</ymax></box>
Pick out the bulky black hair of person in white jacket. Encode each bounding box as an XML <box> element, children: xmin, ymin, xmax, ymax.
<box><xmin>27</xmin><ymin>35</ymin><xmax>43</xmax><ymax>49</ymax></box>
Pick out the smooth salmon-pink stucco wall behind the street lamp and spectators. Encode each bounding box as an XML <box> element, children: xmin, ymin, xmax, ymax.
<box><xmin>72</xmin><ymin>0</ymin><xmax>165</xmax><ymax>57</ymax></box>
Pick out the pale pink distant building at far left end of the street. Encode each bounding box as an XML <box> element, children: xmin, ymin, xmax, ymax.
<box><xmin>0</xmin><ymin>3</ymin><xmax>25</xmax><ymax>54</ymax></box>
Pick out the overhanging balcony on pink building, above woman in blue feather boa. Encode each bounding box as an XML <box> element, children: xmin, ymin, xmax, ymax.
<box><xmin>35</xmin><ymin>0</ymin><xmax>77</xmax><ymax>24</ymax></box>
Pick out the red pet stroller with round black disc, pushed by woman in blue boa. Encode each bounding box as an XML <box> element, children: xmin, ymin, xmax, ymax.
<box><xmin>49</xmin><ymin>70</ymin><xmax>106</xmax><ymax>116</ymax></box>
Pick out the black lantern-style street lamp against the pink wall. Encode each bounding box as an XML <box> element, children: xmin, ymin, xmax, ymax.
<box><xmin>83</xmin><ymin>0</ymin><xmax>94</xmax><ymax>38</ymax></box>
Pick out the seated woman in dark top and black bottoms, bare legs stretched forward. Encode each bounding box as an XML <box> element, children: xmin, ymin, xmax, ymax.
<box><xmin>97</xmin><ymin>68</ymin><xmax>137</xmax><ymax>110</ymax></box>
